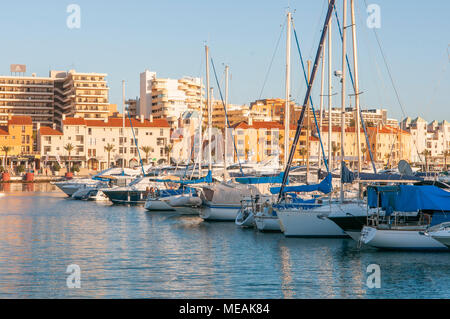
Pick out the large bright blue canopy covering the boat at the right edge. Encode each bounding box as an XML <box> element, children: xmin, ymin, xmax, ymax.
<box><xmin>367</xmin><ymin>185</ymin><xmax>450</xmax><ymax>214</ymax></box>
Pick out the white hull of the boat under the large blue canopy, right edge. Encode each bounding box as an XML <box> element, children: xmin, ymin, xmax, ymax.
<box><xmin>361</xmin><ymin>226</ymin><xmax>448</xmax><ymax>250</ymax></box>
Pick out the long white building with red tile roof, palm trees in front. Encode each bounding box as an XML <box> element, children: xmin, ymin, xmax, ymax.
<box><xmin>38</xmin><ymin>116</ymin><xmax>170</xmax><ymax>170</ymax></box>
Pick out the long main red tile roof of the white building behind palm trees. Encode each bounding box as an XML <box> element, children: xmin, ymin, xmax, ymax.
<box><xmin>63</xmin><ymin>117</ymin><xmax>170</xmax><ymax>128</ymax></box>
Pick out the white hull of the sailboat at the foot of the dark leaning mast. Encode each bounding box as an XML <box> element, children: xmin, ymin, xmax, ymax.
<box><xmin>277</xmin><ymin>205</ymin><xmax>348</xmax><ymax>237</ymax></box>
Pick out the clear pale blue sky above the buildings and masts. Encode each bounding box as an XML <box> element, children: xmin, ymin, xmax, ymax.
<box><xmin>0</xmin><ymin>0</ymin><xmax>450</xmax><ymax>121</ymax></box>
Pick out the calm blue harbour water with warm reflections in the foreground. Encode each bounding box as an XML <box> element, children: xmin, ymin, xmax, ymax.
<box><xmin>0</xmin><ymin>184</ymin><xmax>450</xmax><ymax>298</ymax></box>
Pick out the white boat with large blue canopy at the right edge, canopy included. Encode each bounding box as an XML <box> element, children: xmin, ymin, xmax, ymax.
<box><xmin>360</xmin><ymin>185</ymin><xmax>450</xmax><ymax>251</ymax></box>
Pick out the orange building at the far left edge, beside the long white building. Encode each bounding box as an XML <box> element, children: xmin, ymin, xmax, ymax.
<box><xmin>0</xmin><ymin>115</ymin><xmax>36</xmax><ymax>167</ymax></box>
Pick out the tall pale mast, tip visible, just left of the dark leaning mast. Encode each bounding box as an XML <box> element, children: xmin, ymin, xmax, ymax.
<box><xmin>284</xmin><ymin>11</ymin><xmax>291</xmax><ymax>167</ymax></box>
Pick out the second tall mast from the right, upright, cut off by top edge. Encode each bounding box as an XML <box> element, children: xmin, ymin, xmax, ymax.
<box><xmin>340</xmin><ymin>0</ymin><xmax>347</xmax><ymax>202</ymax></box>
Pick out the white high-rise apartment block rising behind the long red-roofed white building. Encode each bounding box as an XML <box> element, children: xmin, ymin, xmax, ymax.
<box><xmin>137</xmin><ymin>70</ymin><xmax>202</xmax><ymax>126</ymax></box>
